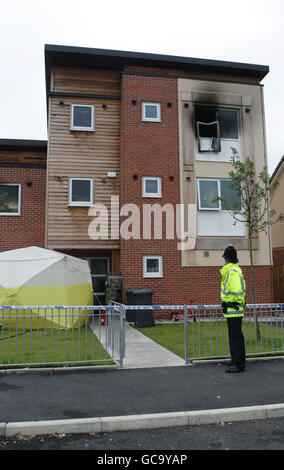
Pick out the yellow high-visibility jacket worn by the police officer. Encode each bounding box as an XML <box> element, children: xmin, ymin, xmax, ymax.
<box><xmin>220</xmin><ymin>263</ymin><xmax>246</xmax><ymax>318</ymax></box>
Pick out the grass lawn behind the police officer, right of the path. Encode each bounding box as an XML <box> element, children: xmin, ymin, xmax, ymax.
<box><xmin>137</xmin><ymin>320</ymin><xmax>284</xmax><ymax>359</ymax></box>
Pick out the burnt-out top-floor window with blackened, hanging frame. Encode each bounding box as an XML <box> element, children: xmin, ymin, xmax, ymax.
<box><xmin>195</xmin><ymin>106</ymin><xmax>239</xmax><ymax>160</ymax></box>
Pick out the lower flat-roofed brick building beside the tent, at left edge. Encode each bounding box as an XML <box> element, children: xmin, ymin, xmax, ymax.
<box><xmin>0</xmin><ymin>139</ymin><xmax>47</xmax><ymax>251</ymax></box>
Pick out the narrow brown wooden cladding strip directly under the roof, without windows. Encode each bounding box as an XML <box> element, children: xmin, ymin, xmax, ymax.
<box><xmin>51</xmin><ymin>67</ymin><xmax>120</xmax><ymax>96</ymax></box>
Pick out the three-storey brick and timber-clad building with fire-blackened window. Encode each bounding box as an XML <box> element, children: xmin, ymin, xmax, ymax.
<box><xmin>0</xmin><ymin>45</ymin><xmax>273</xmax><ymax>304</ymax></box>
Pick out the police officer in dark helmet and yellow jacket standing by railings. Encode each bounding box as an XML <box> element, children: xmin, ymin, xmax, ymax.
<box><xmin>220</xmin><ymin>245</ymin><xmax>246</xmax><ymax>373</ymax></box>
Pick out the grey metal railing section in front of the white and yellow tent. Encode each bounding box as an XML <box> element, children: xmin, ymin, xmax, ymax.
<box><xmin>0</xmin><ymin>304</ymin><xmax>125</xmax><ymax>368</ymax></box>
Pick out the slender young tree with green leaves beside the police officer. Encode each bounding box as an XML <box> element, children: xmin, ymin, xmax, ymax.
<box><xmin>218</xmin><ymin>148</ymin><xmax>284</xmax><ymax>337</ymax></box>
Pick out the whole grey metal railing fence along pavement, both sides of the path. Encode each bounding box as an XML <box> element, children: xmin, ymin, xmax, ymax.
<box><xmin>0</xmin><ymin>302</ymin><xmax>284</xmax><ymax>368</ymax></box>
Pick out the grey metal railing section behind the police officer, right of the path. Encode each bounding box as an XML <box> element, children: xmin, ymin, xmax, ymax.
<box><xmin>184</xmin><ymin>304</ymin><xmax>284</xmax><ymax>364</ymax></box>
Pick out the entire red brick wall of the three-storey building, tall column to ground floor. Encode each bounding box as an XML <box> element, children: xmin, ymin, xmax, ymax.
<box><xmin>120</xmin><ymin>70</ymin><xmax>272</xmax><ymax>304</ymax></box>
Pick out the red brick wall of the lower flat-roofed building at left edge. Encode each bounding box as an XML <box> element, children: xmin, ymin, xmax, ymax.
<box><xmin>0</xmin><ymin>166</ymin><xmax>46</xmax><ymax>251</ymax></box>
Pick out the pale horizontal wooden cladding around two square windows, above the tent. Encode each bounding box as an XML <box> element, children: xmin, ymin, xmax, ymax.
<box><xmin>47</xmin><ymin>95</ymin><xmax>120</xmax><ymax>248</ymax></box>
